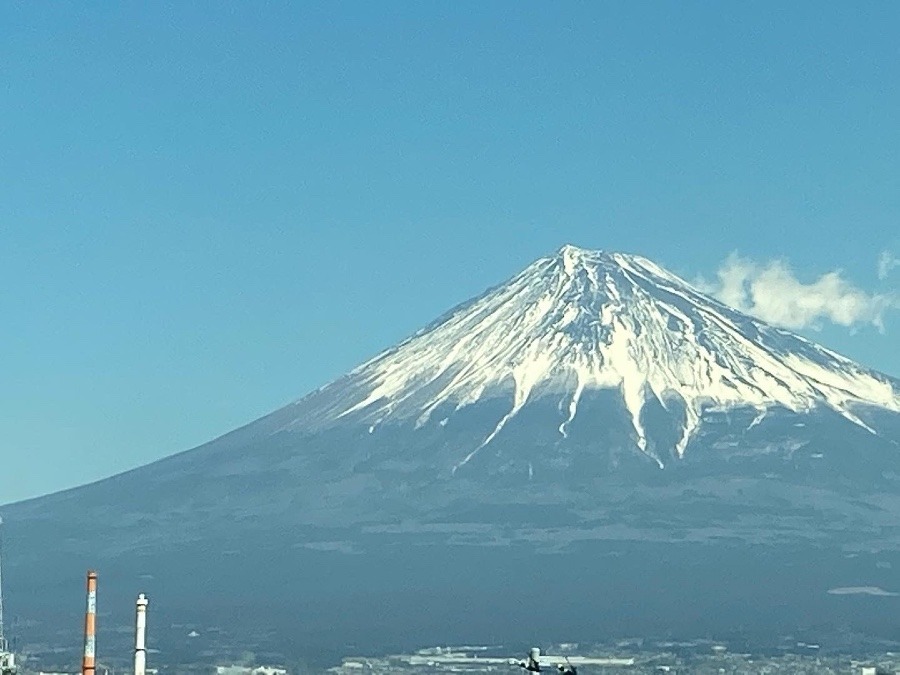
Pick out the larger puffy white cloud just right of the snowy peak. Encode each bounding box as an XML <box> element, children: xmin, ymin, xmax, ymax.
<box><xmin>700</xmin><ymin>253</ymin><xmax>900</xmax><ymax>330</ymax></box>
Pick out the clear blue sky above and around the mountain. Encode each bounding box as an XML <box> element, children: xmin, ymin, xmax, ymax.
<box><xmin>0</xmin><ymin>0</ymin><xmax>900</xmax><ymax>504</ymax></box>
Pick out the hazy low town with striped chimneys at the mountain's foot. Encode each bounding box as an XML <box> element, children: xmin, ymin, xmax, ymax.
<box><xmin>0</xmin><ymin>571</ymin><xmax>900</xmax><ymax>675</ymax></box>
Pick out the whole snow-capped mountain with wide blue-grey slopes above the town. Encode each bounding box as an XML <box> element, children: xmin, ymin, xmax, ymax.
<box><xmin>3</xmin><ymin>246</ymin><xmax>900</xmax><ymax>664</ymax></box>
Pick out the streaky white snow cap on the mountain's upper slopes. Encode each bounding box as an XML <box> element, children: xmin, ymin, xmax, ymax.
<box><xmin>288</xmin><ymin>246</ymin><xmax>900</xmax><ymax>466</ymax></box>
